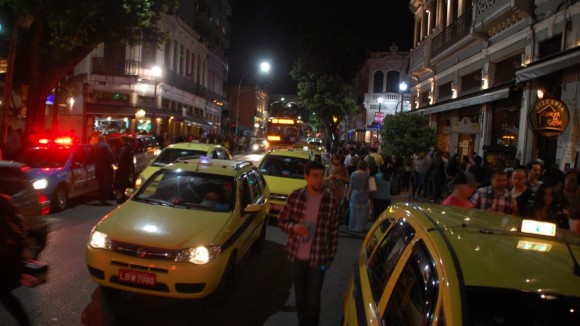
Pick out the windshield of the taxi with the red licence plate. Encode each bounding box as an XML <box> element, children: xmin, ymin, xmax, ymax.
<box><xmin>133</xmin><ymin>170</ymin><xmax>236</xmax><ymax>212</ymax></box>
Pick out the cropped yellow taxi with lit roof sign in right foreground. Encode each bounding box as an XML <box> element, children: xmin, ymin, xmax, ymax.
<box><xmin>343</xmin><ymin>203</ymin><xmax>580</xmax><ymax>325</ymax></box>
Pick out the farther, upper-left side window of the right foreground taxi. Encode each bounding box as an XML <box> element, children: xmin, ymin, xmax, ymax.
<box><xmin>368</xmin><ymin>220</ymin><xmax>415</xmax><ymax>300</ymax></box>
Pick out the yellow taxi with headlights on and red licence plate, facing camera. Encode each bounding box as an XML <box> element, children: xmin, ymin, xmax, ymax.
<box><xmin>86</xmin><ymin>157</ymin><xmax>270</xmax><ymax>299</ymax></box>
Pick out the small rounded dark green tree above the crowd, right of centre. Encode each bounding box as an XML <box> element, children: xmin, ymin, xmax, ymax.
<box><xmin>381</xmin><ymin>113</ymin><xmax>436</xmax><ymax>158</ymax></box>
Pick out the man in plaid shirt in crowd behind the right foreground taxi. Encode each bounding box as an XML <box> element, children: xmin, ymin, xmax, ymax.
<box><xmin>470</xmin><ymin>170</ymin><xmax>518</xmax><ymax>215</ymax></box>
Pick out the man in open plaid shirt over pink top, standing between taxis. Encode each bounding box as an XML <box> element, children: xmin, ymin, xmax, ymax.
<box><xmin>278</xmin><ymin>161</ymin><xmax>339</xmax><ymax>325</ymax></box>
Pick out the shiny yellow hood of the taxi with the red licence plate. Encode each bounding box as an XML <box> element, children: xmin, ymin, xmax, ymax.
<box><xmin>96</xmin><ymin>200</ymin><xmax>232</xmax><ymax>249</ymax></box>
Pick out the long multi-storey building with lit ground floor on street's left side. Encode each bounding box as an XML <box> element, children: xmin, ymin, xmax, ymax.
<box><xmin>59</xmin><ymin>0</ymin><xmax>231</xmax><ymax>143</ymax></box>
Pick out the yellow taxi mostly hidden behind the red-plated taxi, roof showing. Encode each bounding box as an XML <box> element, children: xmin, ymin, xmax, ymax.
<box><xmin>135</xmin><ymin>142</ymin><xmax>232</xmax><ymax>188</ymax></box>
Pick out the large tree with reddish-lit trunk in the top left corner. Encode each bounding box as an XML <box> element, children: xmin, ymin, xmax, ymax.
<box><xmin>0</xmin><ymin>0</ymin><xmax>178</xmax><ymax>136</ymax></box>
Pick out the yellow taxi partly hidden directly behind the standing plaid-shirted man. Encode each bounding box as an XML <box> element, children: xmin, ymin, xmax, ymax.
<box><xmin>258</xmin><ymin>148</ymin><xmax>314</xmax><ymax>217</ymax></box>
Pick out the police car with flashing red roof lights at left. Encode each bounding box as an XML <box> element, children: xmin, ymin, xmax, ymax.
<box><xmin>22</xmin><ymin>137</ymin><xmax>99</xmax><ymax>212</ymax></box>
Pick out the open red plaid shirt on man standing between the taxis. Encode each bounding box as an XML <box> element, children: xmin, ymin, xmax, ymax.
<box><xmin>278</xmin><ymin>188</ymin><xmax>339</xmax><ymax>268</ymax></box>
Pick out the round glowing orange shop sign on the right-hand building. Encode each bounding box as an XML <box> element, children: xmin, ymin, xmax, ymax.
<box><xmin>528</xmin><ymin>98</ymin><xmax>570</xmax><ymax>137</ymax></box>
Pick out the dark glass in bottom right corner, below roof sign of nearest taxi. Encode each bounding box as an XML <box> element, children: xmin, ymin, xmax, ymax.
<box><xmin>466</xmin><ymin>286</ymin><xmax>580</xmax><ymax>325</ymax></box>
